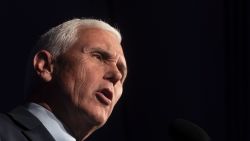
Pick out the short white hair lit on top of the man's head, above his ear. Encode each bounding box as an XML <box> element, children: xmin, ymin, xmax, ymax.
<box><xmin>35</xmin><ymin>19</ymin><xmax>122</xmax><ymax>59</ymax></box>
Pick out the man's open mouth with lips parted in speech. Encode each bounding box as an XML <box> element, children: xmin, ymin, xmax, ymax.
<box><xmin>96</xmin><ymin>88</ymin><xmax>113</xmax><ymax>105</ymax></box>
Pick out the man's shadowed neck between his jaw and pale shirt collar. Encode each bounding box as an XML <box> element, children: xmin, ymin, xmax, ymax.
<box><xmin>29</xmin><ymin>93</ymin><xmax>97</xmax><ymax>141</ymax></box>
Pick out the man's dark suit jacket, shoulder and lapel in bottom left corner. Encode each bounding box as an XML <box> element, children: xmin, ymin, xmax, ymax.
<box><xmin>0</xmin><ymin>106</ymin><xmax>55</xmax><ymax>141</ymax></box>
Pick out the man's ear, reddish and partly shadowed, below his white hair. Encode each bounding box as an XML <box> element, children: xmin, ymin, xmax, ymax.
<box><xmin>33</xmin><ymin>50</ymin><xmax>53</xmax><ymax>82</ymax></box>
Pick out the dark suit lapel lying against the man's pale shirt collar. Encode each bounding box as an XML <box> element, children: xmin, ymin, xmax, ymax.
<box><xmin>8</xmin><ymin>106</ymin><xmax>55</xmax><ymax>141</ymax></box>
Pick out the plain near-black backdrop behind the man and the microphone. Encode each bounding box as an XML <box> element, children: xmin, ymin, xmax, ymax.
<box><xmin>0</xmin><ymin>0</ymin><xmax>250</xmax><ymax>141</ymax></box>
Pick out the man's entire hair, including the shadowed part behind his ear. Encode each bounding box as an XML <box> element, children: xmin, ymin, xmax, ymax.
<box><xmin>24</xmin><ymin>18</ymin><xmax>122</xmax><ymax>95</ymax></box>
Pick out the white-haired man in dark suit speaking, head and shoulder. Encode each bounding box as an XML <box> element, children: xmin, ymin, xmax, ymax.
<box><xmin>0</xmin><ymin>19</ymin><xmax>127</xmax><ymax>141</ymax></box>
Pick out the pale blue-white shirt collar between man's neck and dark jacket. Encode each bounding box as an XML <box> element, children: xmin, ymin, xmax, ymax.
<box><xmin>27</xmin><ymin>103</ymin><xmax>76</xmax><ymax>141</ymax></box>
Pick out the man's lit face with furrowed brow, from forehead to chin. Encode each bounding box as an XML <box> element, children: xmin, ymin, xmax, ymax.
<box><xmin>55</xmin><ymin>28</ymin><xmax>127</xmax><ymax>126</ymax></box>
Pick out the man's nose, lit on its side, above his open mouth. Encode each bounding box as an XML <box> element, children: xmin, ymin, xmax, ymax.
<box><xmin>104</xmin><ymin>64</ymin><xmax>122</xmax><ymax>85</ymax></box>
